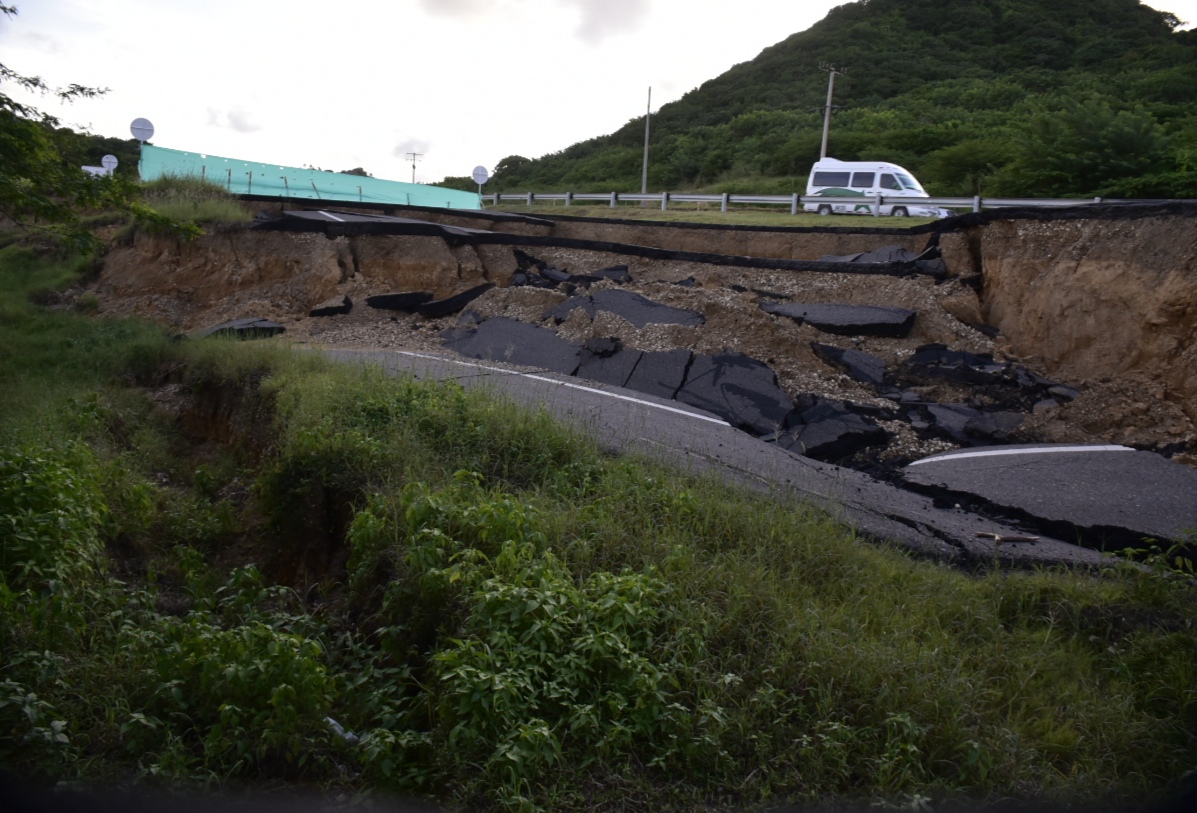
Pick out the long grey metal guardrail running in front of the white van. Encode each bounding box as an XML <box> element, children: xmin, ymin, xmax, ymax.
<box><xmin>481</xmin><ymin>192</ymin><xmax>1102</xmax><ymax>217</ymax></box>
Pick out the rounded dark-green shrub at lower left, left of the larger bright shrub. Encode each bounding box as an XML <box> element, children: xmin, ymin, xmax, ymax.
<box><xmin>120</xmin><ymin>566</ymin><xmax>335</xmax><ymax>779</ymax></box>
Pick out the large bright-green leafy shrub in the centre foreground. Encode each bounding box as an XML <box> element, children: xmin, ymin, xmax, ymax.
<box><xmin>350</xmin><ymin>472</ymin><xmax>722</xmax><ymax>806</ymax></box>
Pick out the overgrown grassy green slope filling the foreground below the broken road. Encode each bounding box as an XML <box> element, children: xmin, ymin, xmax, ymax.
<box><xmin>0</xmin><ymin>247</ymin><xmax>1197</xmax><ymax>809</ymax></box>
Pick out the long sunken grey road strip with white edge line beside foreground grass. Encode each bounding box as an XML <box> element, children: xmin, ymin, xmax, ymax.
<box><xmin>323</xmin><ymin>348</ymin><xmax>1102</xmax><ymax>565</ymax></box>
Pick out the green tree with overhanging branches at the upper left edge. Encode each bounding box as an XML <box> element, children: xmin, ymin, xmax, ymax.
<box><xmin>0</xmin><ymin>5</ymin><xmax>187</xmax><ymax>248</ymax></box>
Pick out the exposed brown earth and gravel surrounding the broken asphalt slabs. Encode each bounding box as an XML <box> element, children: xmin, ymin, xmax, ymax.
<box><xmin>95</xmin><ymin>211</ymin><xmax>1197</xmax><ymax>465</ymax></box>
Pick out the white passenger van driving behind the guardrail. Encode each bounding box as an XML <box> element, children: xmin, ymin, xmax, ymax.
<box><xmin>803</xmin><ymin>158</ymin><xmax>952</xmax><ymax>218</ymax></box>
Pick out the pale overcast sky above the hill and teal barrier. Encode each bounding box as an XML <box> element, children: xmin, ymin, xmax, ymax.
<box><xmin>0</xmin><ymin>0</ymin><xmax>1197</xmax><ymax>182</ymax></box>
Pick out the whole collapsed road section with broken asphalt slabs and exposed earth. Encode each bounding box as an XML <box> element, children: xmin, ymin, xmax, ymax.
<box><xmin>86</xmin><ymin>197</ymin><xmax>1197</xmax><ymax>563</ymax></box>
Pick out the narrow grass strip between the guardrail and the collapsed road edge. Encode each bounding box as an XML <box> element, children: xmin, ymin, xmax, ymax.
<box><xmin>488</xmin><ymin>204</ymin><xmax>935</xmax><ymax>229</ymax></box>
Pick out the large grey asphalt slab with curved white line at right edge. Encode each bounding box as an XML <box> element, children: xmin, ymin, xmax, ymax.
<box><xmin>903</xmin><ymin>444</ymin><xmax>1197</xmax><ymax>550</ymax></box>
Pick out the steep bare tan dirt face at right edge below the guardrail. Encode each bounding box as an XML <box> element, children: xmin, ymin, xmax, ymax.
<box><xmin>977</xmin><ymin>217</ymin><xmax>1197</xmax><ymax>438</ymax></box>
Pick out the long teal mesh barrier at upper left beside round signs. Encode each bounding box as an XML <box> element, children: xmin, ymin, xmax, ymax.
<box><xmin>138</xmin><ymin>144</ymin><xmax>482</xmax><ymax>210</ymax></box>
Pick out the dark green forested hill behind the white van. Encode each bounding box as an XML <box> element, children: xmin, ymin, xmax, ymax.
<box><xmin>474</xmin><ymin>0</ymin><xmax>1197</xmax><ymax>198</ymax></box>
